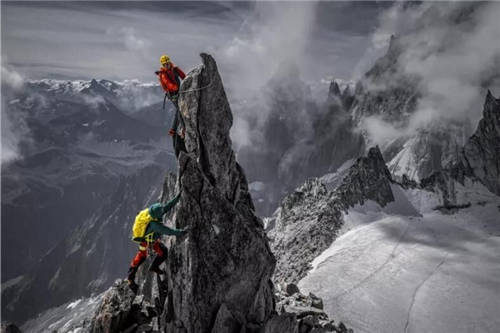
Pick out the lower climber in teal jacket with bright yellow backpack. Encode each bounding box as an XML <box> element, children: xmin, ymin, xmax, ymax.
<box><xmin>128</xmin><ymin>193</ymin><xmax>187</xmax><ymax>292</ymax></box>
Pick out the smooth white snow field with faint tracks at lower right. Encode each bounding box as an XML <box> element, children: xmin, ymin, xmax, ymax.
<box><xmin>299</xmin><ymin>184</ymin><xmax>500</xmax><ymax>333</ymax></box>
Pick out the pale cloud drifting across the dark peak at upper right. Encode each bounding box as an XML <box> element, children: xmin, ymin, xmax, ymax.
<box><xmin>362</xmin><ymin>2</ymin><xmax>500</xmax><ymax>141</ymax></box>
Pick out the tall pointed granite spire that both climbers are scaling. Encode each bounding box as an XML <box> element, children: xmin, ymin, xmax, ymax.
<box><xmin>163</xmin><ymin>54</ymin><xmax>275</xmax><ymax>332</ymax></box>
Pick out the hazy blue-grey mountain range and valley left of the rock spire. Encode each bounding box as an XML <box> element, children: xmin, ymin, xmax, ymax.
<box><xmin>2</xmin><ymin>80</ymin><xmax>175</xmax><ymax>321</ymax></box>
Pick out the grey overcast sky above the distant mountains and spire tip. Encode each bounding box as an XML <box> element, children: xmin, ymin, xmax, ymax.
<box><xmin>2</xmin><ymin>2</ymin><xmax>390</xmax><ymax>85</ymax></box>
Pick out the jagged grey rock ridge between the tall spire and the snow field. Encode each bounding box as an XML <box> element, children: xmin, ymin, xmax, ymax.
<box><xmin>268</xmin><ymin>147</ymin><xmax>394</xmax><ymax>282</ymax></box>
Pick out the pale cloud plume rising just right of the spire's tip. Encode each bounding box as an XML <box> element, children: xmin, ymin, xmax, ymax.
<box><xmin>213</xmin><ymin>2</ymin><xmax>319</xmax><ymax>148</ymax></box>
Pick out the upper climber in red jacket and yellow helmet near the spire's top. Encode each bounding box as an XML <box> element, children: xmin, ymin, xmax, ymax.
<box><xmin>155</xmin><ymin>54</ymin><xmax>186</xmax><ymax>156</ymax></box>
